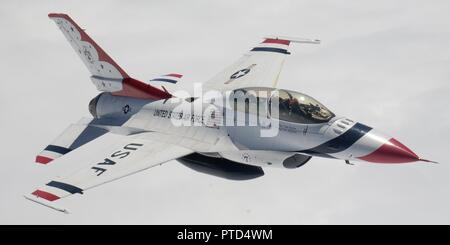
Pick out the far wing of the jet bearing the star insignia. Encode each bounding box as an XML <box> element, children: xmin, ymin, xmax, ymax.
<box><xmin>203</xmin><ymin>37</ymin><xmax>320</xmax><ymax>91</ymax></box>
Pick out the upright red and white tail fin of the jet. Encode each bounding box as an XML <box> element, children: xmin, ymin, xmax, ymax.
<box><xmin>48</xmin><ymin>13</ymin><xmax>171</xmax><ymax>99</ymax></box>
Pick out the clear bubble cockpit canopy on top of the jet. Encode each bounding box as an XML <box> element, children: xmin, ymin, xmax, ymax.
<box><xmin>235</xmin><ymin>88</ymin><xmax>335</xmax><ymax>124</ymax></box>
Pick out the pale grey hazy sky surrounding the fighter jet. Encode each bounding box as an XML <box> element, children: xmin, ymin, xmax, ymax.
<box><xmin>0</xmin><ymin>0</ymin><xmax>450</xmax><ymax>224</ymax></box>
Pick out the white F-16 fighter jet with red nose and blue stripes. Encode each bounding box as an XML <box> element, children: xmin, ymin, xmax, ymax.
<box><xmin>25</xmin><ymin>13</ymin><xmax>429</xmax><ymax>212</ymax></box>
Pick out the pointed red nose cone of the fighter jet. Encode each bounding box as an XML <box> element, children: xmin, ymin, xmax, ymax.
<box><xmin>359</xmin><ymin>138</ymin><xmax>420</xmax><ymax>163</ymax></box>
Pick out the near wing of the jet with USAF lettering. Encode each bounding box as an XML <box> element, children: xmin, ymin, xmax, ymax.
<box><xmin>25</xmin><ymin>132</ymin><xmax>193</xmax><ymax>212</ymax></box>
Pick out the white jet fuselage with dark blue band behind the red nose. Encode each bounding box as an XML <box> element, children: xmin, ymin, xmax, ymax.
<box><xmin>91</xmin><ymin>89</ymin><xmax>420</xmax><ymax>167</ymax></box>
